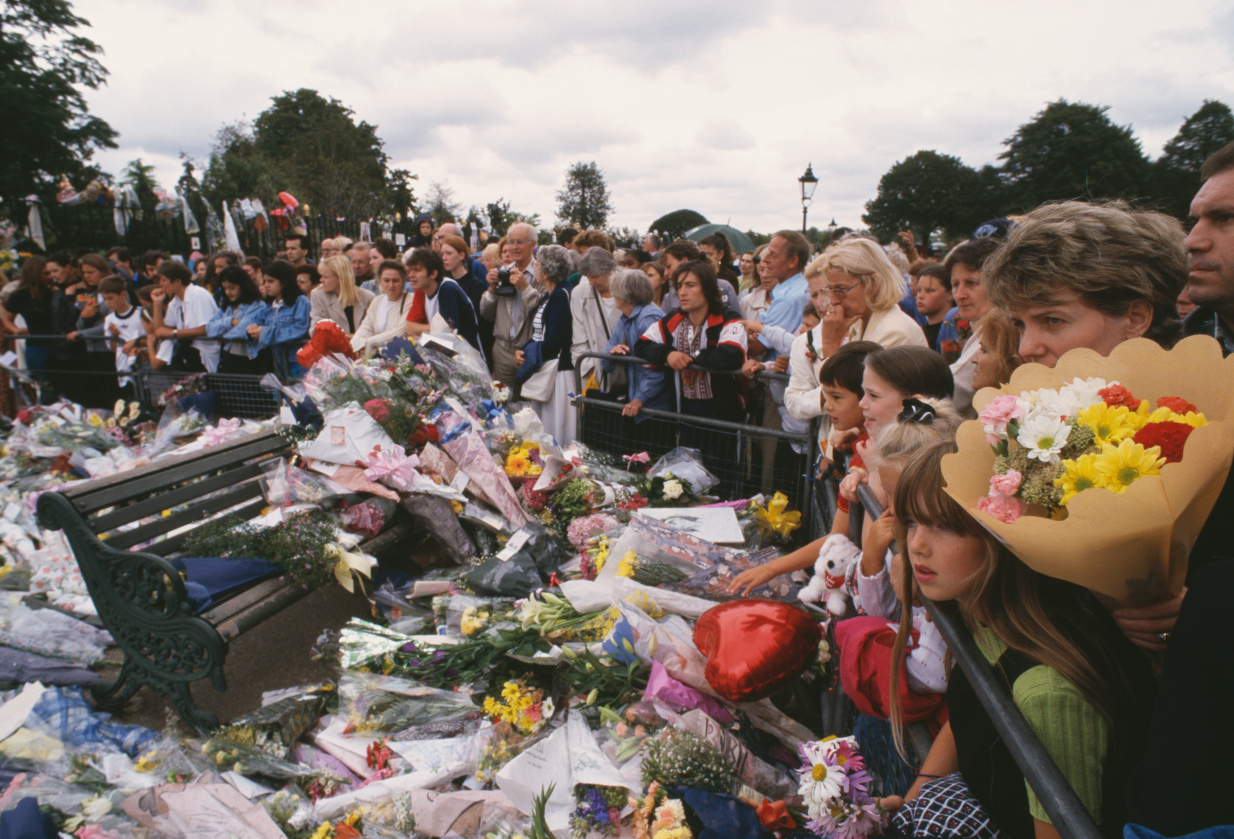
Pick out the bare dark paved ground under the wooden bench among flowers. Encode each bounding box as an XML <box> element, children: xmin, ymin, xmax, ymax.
<box><xmin>105</xmin><ymin>586</ymin><xmax>369</xmax><ymax>729</ymax></box>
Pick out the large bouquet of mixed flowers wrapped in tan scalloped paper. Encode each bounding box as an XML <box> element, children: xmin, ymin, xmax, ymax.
<box><xmin>943</xmin><ymin>336</ymin><xmax>1234</xmax><ymax>606</ymax></box>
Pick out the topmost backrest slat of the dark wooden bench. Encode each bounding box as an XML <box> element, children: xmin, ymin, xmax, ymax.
<box><xmin>63</xmin><ymin>432</ymin><xmax>289</xmax><ymax>516</ymax></box>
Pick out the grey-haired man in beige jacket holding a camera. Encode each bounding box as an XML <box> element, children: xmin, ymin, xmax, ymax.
<box><xmin>480</xmin><ymin>222</ymin><xmax>543</xmax><ymax>391</ymax></box>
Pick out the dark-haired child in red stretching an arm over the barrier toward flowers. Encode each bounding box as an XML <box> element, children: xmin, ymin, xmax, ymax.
<box><xmin>728</xmin><ymin>341</ymin><xmax>881</xmax><ymax>596</ymax></box>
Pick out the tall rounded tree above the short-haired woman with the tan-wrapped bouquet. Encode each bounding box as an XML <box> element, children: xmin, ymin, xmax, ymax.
<box><xmin>998</xmin><ymin>99</ymin><xmax>1149</xmax><ymax>211</ymax></box>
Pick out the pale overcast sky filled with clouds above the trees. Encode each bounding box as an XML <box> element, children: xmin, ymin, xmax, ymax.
<box><xmin>74</xmin><ymin>0</ymin><xmax>1234</xmax><ymax>238</ymax></box>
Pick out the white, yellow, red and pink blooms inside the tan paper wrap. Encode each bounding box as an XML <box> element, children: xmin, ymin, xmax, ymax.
<box><xmin>977</xmin><ymin>378</ymin><xmax>1208</xmax><ymax>523</ymax></box>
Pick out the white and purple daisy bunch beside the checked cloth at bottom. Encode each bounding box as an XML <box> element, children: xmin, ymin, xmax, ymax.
<box><xmin>797</xmin><ymin>737</ymin><xmax>887</xmax><ymax>839</ymax></box>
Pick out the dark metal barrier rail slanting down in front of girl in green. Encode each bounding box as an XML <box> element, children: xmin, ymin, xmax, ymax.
<box><xmin>849</xmin><ymin>484</ymin><xmax>1102</xmax><ymax>839</ymax></box>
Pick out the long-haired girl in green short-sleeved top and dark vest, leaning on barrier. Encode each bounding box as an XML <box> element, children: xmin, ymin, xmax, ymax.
<box><xmin>888</xmin><ymin>442</ymin><xmax>1155</xmax><ymax>839</ymax></box>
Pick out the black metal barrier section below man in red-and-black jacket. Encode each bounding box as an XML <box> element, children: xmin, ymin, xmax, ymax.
<box><xmin>571</xmin><ymin>353</ymin><xmax>829</xmax><ymax>542</ymax></box>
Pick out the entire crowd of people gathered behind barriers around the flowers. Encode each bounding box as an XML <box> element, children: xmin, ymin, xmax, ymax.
<box><xmin>0</xmin><ymin>144</ymin><xmax>1234</xmax><ymax>839</ymax></box>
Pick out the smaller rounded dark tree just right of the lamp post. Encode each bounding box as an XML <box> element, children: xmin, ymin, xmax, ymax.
<box><xmin>861</xmin><ymin>151</ymin><xmax>993</xmax><ymax>242</ymax></box>
